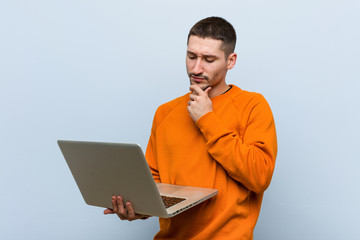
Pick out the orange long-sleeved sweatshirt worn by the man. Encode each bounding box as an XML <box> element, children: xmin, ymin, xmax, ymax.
<box><xmin>146</xmin><ymin>85</ymin><xmax>277</xmax><ymax>240</ymax></box>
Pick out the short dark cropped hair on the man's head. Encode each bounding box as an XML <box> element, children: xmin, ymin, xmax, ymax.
<box><xmin>187</xmin><ymin>17</ymin><xmax>236</xmax><ymax>58</ymax></box>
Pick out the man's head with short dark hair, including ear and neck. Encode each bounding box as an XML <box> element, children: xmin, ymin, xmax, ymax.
<box><xmin>186</xmin><ymin>17</ymin><xmax>237</xmax><ymax>97</ymax></box>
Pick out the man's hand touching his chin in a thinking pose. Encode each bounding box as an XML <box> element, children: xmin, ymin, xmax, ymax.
<box><xmin>187</xmin><ymin>85</ymin><xmax>213</xmax><ymax>122</ymax></box>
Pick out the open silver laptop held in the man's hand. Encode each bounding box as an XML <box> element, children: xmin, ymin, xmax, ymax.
<box><xmin>58</xmin><ymin>140</ymin><xmax>218</xmax><ymax>218</ymax></box>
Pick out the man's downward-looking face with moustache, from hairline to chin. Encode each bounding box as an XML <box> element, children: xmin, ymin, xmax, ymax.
<box><xmin>186</xmin><ymin>36</ymin><xmax>228</xmax><ymax>91</ymax></box>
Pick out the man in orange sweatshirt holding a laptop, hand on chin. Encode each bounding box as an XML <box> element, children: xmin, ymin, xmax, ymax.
<box><xmin>104</xmin><ymin>17</ymin><xmax>277</xmax><ymax>239</ymax></box>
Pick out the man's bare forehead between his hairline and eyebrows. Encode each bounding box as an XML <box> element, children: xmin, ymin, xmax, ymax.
<box><xmin>187</xmin><ymin>36</ymin><xmax>224</xmax><ymax>55</ymax></box>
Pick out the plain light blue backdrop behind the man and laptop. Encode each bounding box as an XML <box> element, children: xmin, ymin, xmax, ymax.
<box><xmin>0</xmin><ymin>0</ymin><xmax>360</xmax><ymax>240</ymax></box>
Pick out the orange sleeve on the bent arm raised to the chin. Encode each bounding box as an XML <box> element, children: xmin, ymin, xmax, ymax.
<box><xmin>196</xmin><ymin>94</ymin><xmax>277</xmax><ymax>193</ymax></box>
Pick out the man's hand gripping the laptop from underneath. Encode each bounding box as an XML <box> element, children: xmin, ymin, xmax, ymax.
<box><xmin>104</xmin><ymin>196</ymin><xmax>149</xmax><ymax>221</ymax></box>
